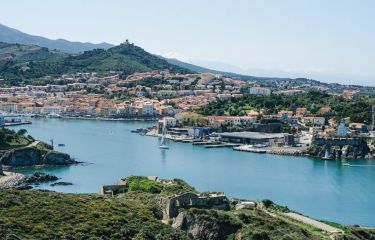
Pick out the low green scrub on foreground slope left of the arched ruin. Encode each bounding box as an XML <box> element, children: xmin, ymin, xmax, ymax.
<box><xmin>0</xmin><ymin>190</ymin><xmax>187</xmax><ymax>239</ymax></box>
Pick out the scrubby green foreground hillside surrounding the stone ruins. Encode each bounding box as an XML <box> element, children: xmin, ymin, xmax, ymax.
<box><xmin>0</xmin><ymin>176</ymin><xmax>375</xmax><ymax>240</ymax></box>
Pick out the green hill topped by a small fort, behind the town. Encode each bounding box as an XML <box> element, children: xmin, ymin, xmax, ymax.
<box><xmin>0</xmin><ymin>42</ymin><xmax>192</xmax><ymax>85</ymax></box>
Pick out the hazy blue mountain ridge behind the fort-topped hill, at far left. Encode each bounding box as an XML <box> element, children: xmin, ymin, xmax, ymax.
<box><xmin>0</xmin><ymin>24</ymin><xmax>113</xmax><ymax>53</ymax></box>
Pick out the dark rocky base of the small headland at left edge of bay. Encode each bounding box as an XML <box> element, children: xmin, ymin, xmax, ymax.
<box><xmin>0</xmin><ymin>146</ymin><xmax>76</xmax><ymax>167</ymax></box>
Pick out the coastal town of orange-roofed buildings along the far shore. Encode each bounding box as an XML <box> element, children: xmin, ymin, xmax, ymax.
<box><xmin>0</xmin><ymin>71</ymin><xmax>375</xmax><ymax>159</ymax></box>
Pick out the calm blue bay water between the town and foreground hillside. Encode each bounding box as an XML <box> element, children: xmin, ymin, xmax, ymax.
<box><xmin>8</xmin><ymin>119</ymin><xmax>375</xmax><ymax>226</ymax></box>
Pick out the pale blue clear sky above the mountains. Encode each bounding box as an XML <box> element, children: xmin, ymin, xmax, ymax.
<box><xmin>0</xmin><ymin>0</ymin><xmax>375</xmax><ymax>86</ymax></box>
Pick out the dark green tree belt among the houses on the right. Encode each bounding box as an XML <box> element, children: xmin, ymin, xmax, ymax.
<box><xmin>196</xmin><ymin>91</ymin><xmax>375</xmax><ymax>123</ymax></box>
